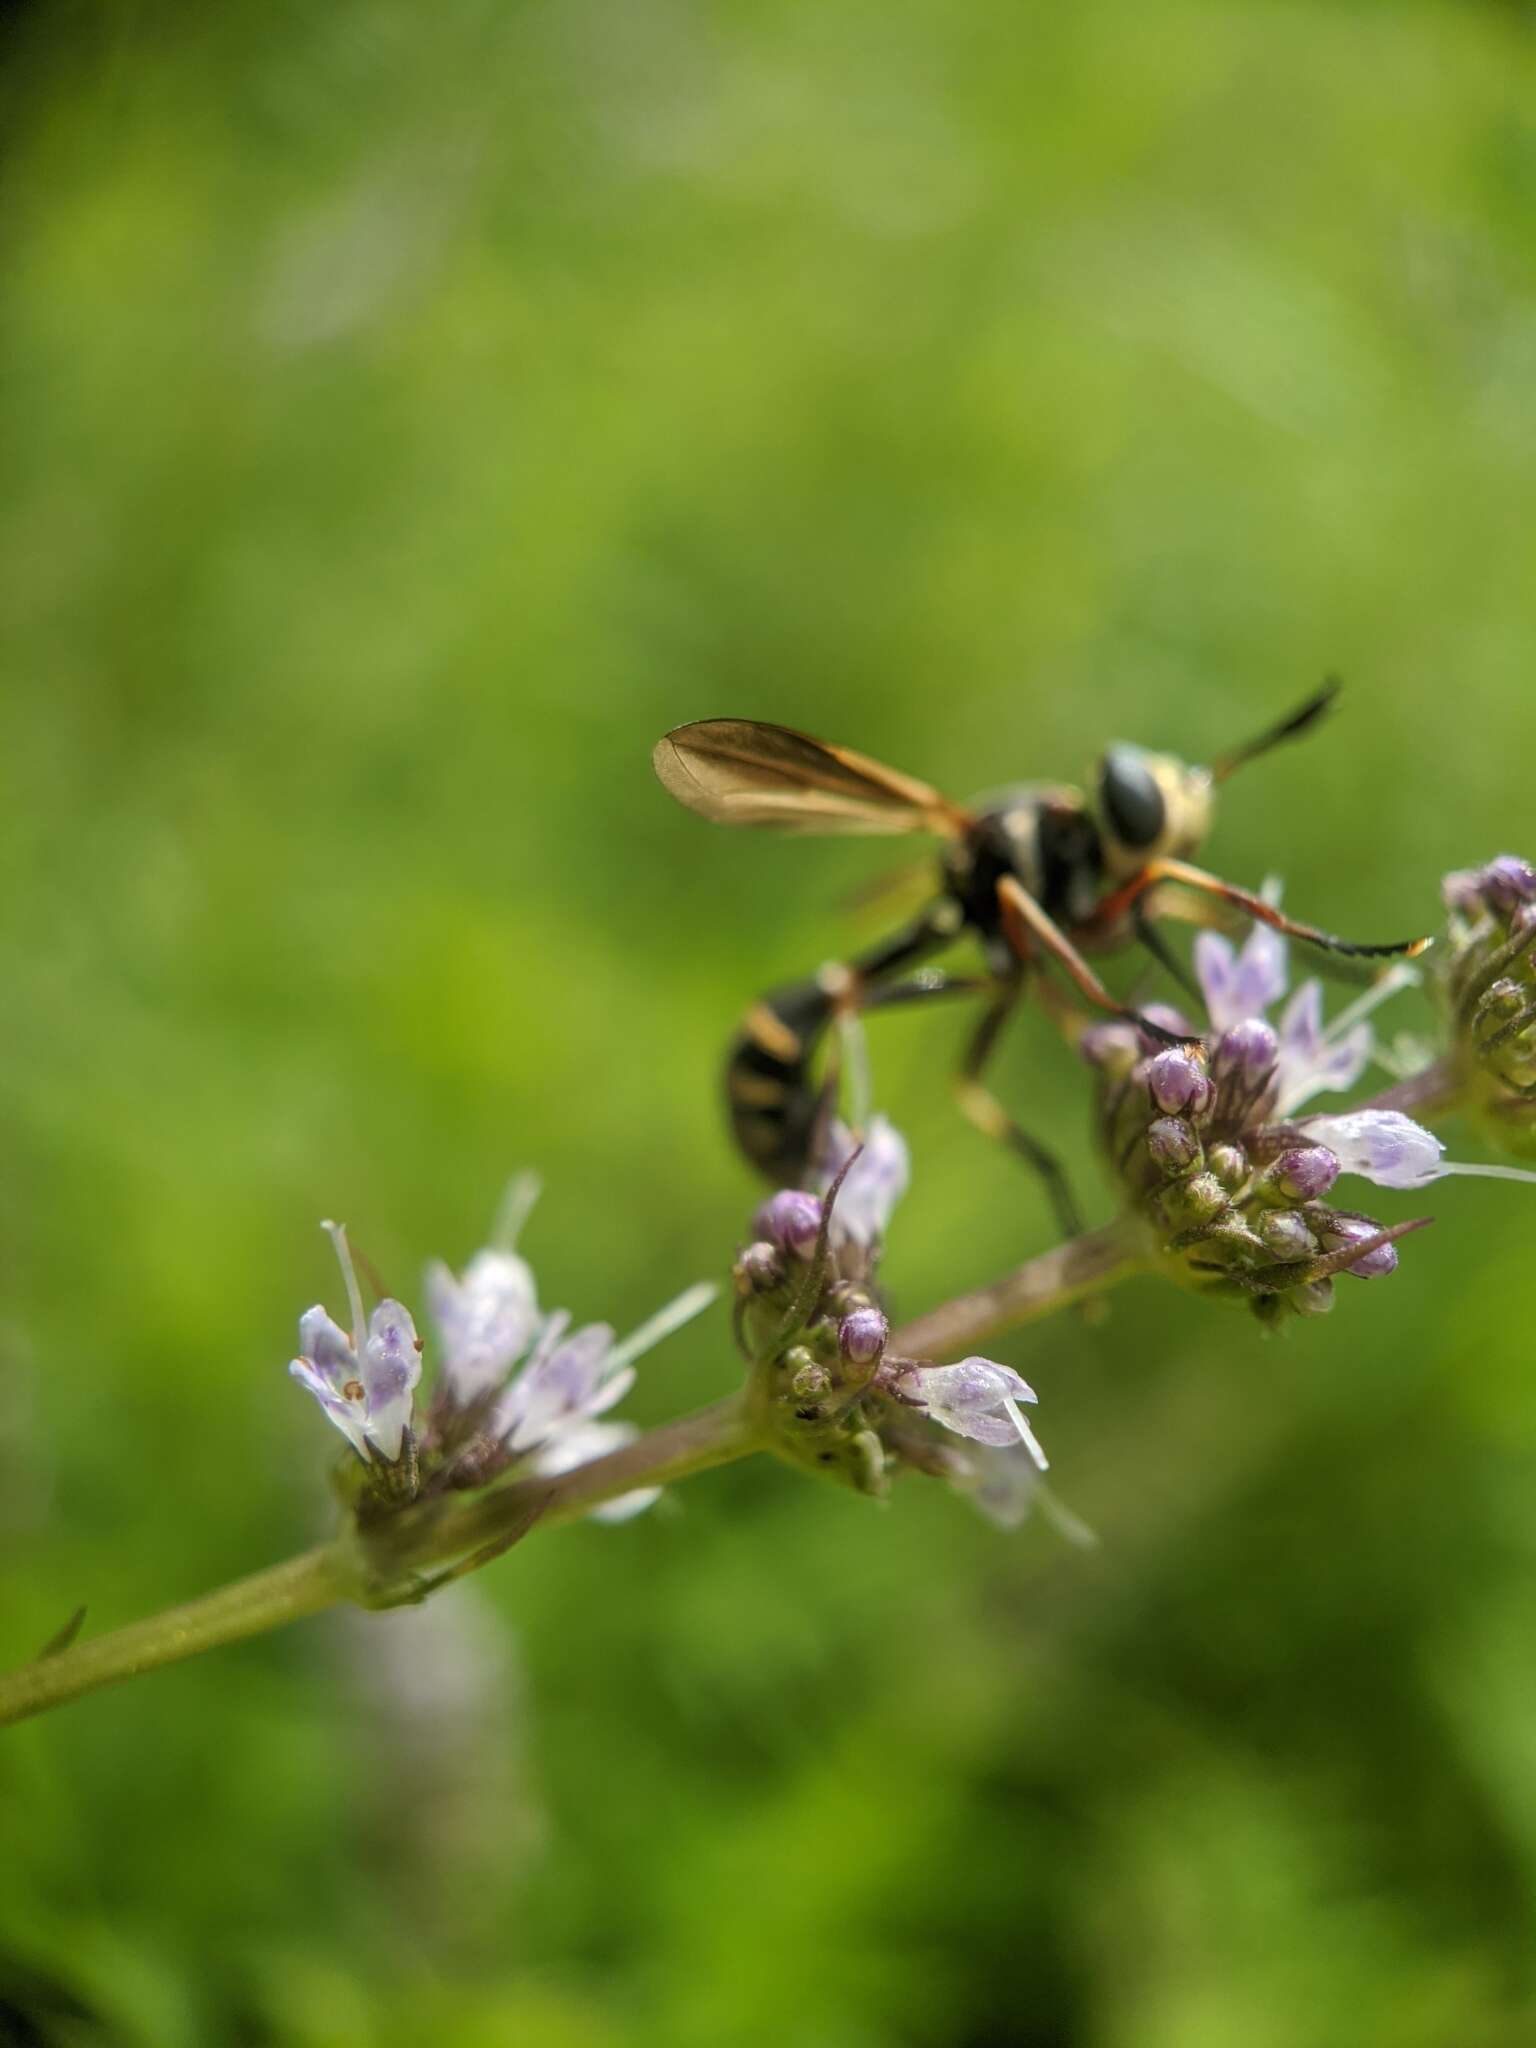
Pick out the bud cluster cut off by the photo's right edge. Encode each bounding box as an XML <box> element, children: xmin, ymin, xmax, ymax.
<box><xmin>1440</xmin><ymin>854</ymin><xmax>1536</xmax><ymax>1157</ymax></box>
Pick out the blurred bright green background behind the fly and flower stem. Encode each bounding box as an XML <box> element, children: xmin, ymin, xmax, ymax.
<box><xmin>0</xmin><ymin>0</ymin><xmax>1536</xmax><ymax>2048</ymax></box>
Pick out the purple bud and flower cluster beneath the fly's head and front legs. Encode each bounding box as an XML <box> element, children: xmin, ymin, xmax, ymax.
<box><xmin>1081</xmin><ymin>924</ymin><xmax>1450</xmax><ymax>1321</ymax></box>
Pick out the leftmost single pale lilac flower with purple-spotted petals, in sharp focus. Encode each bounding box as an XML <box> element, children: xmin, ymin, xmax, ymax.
<box><xmin>289</xmin><ymin>1223</ymin><xmax>422</xmax><ymax>1464</ymax></box>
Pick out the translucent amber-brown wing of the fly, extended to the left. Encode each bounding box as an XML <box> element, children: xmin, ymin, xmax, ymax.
<box><xmin>651</xmin><ymin>719</ymin><xmax>967</xmax><ymax>838</ymax></box>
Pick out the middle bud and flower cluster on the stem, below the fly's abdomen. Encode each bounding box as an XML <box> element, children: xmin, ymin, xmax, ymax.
<box><xmin>733</xmin><ymin>1116</ymin><xmax>1047</xmax><ymax>1522</ymax></box>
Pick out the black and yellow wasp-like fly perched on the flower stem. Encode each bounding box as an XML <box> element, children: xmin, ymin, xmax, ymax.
<box><xmin>653</xmin><ymin>684</ymin><xmax>1430</xmax><ymax>1231</ymax></box>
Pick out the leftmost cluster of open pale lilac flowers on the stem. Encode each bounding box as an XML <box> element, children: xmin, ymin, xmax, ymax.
<box><xmin>289</xmin><ymin>1182</ymin><xmax>717</xmax><ymax>1520</ymax></box>
